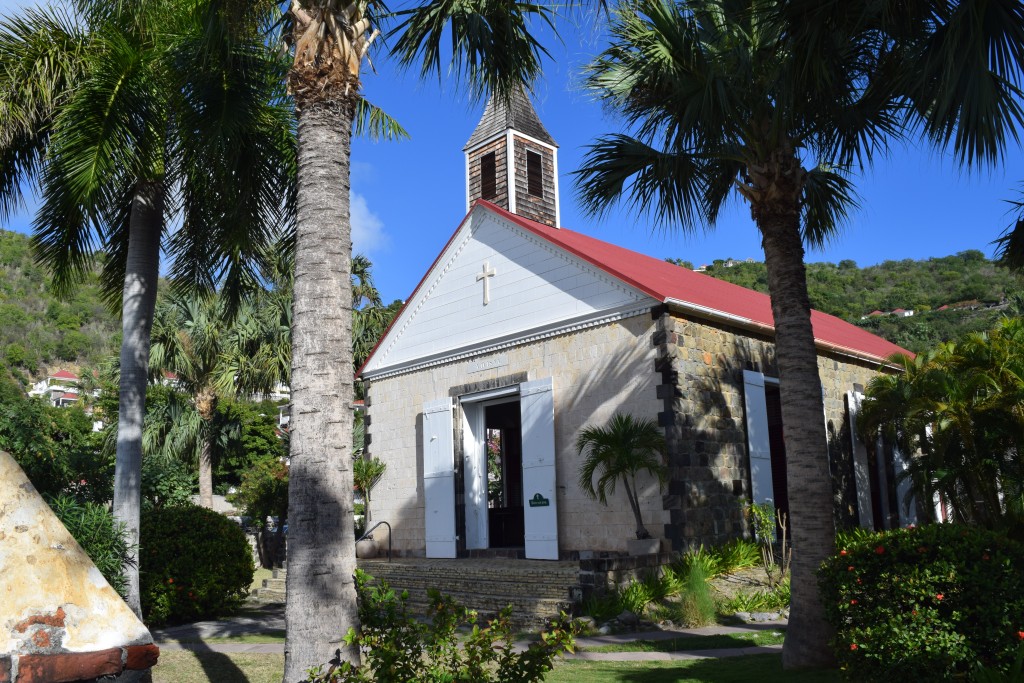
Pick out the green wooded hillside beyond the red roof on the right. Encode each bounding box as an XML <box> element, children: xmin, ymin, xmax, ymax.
<box><xmin>669</xmin><ymin>250</ymin><xmax>1024</xmax><ymax>351</ymax></box>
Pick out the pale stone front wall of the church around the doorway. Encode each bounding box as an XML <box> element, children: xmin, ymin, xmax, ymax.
<box><xmin>367</xmin><ymin>313</ymin><xmax>669</xmax><ymax>557</ymax></box>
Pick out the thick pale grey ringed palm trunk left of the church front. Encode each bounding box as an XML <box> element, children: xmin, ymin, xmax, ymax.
<box><xmin>284</xmin><ymin>94</ymin><xmax>359</xmax><ymax>683</ymax></box>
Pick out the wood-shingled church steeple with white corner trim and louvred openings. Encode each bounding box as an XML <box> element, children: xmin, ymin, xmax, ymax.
<box><xmin>463</xmin><ymin>89</ymin><xmax>559</xmax><ymax>227</ymax></box>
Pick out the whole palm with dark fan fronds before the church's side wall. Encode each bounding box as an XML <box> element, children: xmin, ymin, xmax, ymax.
<box><xmin>577</xmin><ymin>0</ymin><xmax>1024</xmax><ymax>668</ymax></box>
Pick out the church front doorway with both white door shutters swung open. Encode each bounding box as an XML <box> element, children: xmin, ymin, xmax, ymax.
<box><xmin>422</xmin><ymin>378</ymin><xmax>558</xmax><ymax>559</ymax></box>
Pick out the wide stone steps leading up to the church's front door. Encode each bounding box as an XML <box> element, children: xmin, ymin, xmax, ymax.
<box><xmin>253</xmin><ymin>558</ymin><xmax>581</xmax><ymax>630</ymax></box>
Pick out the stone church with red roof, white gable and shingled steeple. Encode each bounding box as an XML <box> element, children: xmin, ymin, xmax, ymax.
<box><xmin>359</xmin><ymin>89</ymin><xmax>910</xmax><ymax>560</ymax></box>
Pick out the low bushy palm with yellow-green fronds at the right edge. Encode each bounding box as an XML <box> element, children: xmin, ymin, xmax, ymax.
<box><xmin>858</xmin><ymin>318</ymin><xmax>1024</xmax><ymax>530</ymax></box>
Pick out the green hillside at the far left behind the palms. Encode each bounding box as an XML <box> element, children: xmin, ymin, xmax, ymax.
<box><xmin>0</xmin><ymin>230</ymin><xmax>121</xmax><ymax>378</ymax></box>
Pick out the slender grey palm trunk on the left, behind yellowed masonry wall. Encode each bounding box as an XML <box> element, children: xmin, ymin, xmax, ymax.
<box><xmin>114</xmin><ymin>181</ymin><xmax>164</xmax><ymax>617</ymax></box>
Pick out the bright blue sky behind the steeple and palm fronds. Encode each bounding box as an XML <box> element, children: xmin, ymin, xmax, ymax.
<box><xmin>0</xmin><ymin>0</ymin><xmax>1024</xmax><ymax>301</ymax></box>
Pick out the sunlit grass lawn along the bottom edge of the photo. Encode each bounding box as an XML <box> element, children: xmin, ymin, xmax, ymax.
<box><xmin>153</xmin><ymin>650</ymin><xmax>842</xmax><ymax>683</ymax></box>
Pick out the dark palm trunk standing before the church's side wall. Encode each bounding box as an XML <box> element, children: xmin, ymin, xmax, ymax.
<box><xmin>758</xmin><ymin>210</ymin><xmax>836</xmax><ymax>669</ymax></box>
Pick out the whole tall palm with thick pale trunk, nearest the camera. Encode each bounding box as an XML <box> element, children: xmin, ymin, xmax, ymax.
<box><xmin>285</xmin><ymin>0</ymin><xmax>552</xmax><ymax>681</ymax></box>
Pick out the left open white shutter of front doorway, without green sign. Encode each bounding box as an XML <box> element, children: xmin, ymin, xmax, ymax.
<box><xmin>423</xmin><ymin>398</ymin><xmax>456</xmax><ymax>557</ymax></box>
